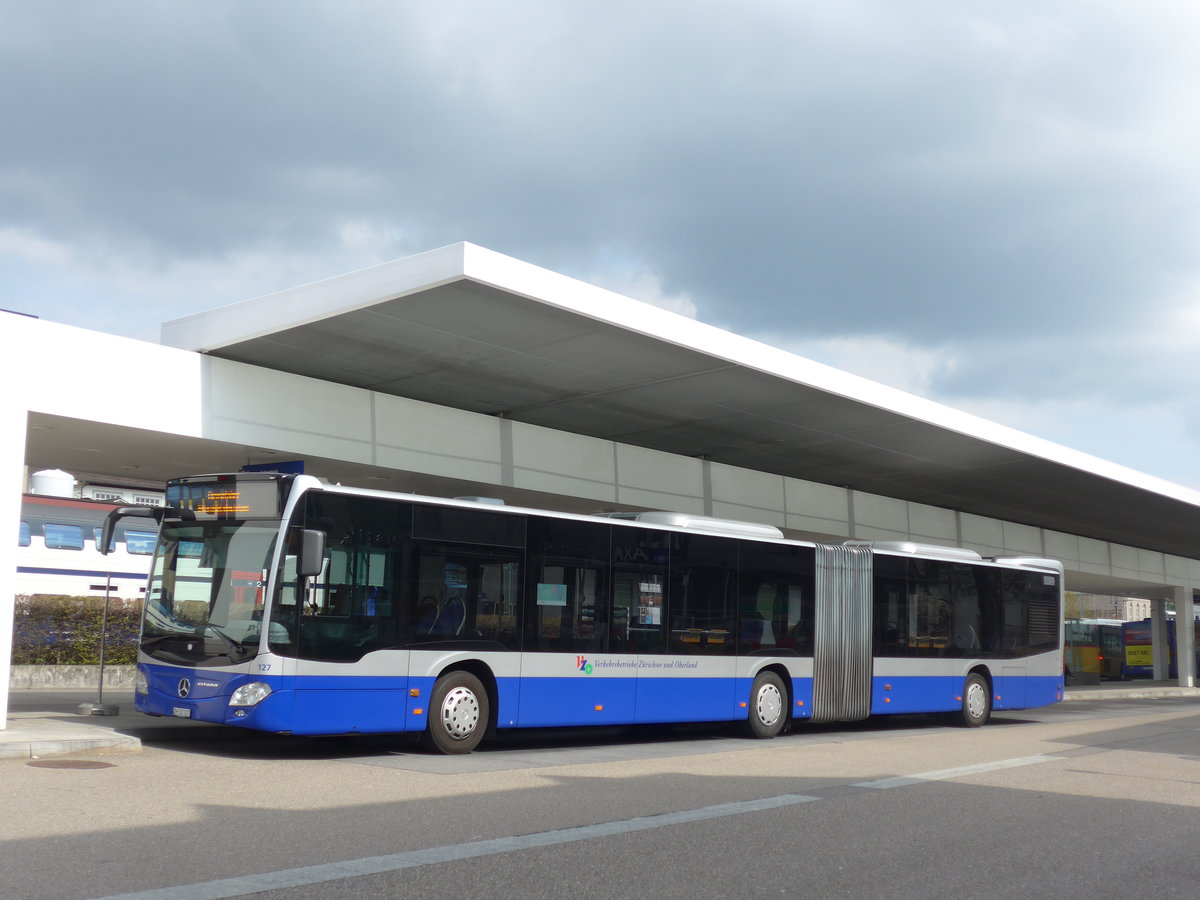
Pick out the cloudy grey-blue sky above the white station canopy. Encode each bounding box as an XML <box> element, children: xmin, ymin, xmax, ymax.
<box><xmin>0</xmin><ymin>0</ymin><xmax>1200</xmax><ymax>487</ymax></box>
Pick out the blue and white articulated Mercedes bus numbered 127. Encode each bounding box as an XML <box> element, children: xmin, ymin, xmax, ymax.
<box><xmin>100</xmin><ymin>474</ymin><xmax>1063</xmax><ymax>752</ymax></box>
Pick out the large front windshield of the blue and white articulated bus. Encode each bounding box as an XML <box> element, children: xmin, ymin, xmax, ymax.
<box><xmin>142</xmin><ymin>522</ymin><xmax>287</xmax><ymax>666</ymax></box>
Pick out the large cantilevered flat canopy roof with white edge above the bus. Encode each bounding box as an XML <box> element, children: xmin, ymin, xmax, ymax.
<box><xmin>163</xmin><ymin>244</ymin><xmax>1200</xmax><ymax>557</ymax></box>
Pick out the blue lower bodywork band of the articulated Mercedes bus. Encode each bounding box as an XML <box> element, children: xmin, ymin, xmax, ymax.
<box><xmin>136</xmin><ymin>664</ymin><xmax>1062</xmax><ymax>734</ymax></box>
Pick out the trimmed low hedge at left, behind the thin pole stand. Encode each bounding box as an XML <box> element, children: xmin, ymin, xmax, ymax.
<box><xmin>12</xmin><ymin>595</ymin><xmax>142</xmax><ymax>666</ymax></box>
